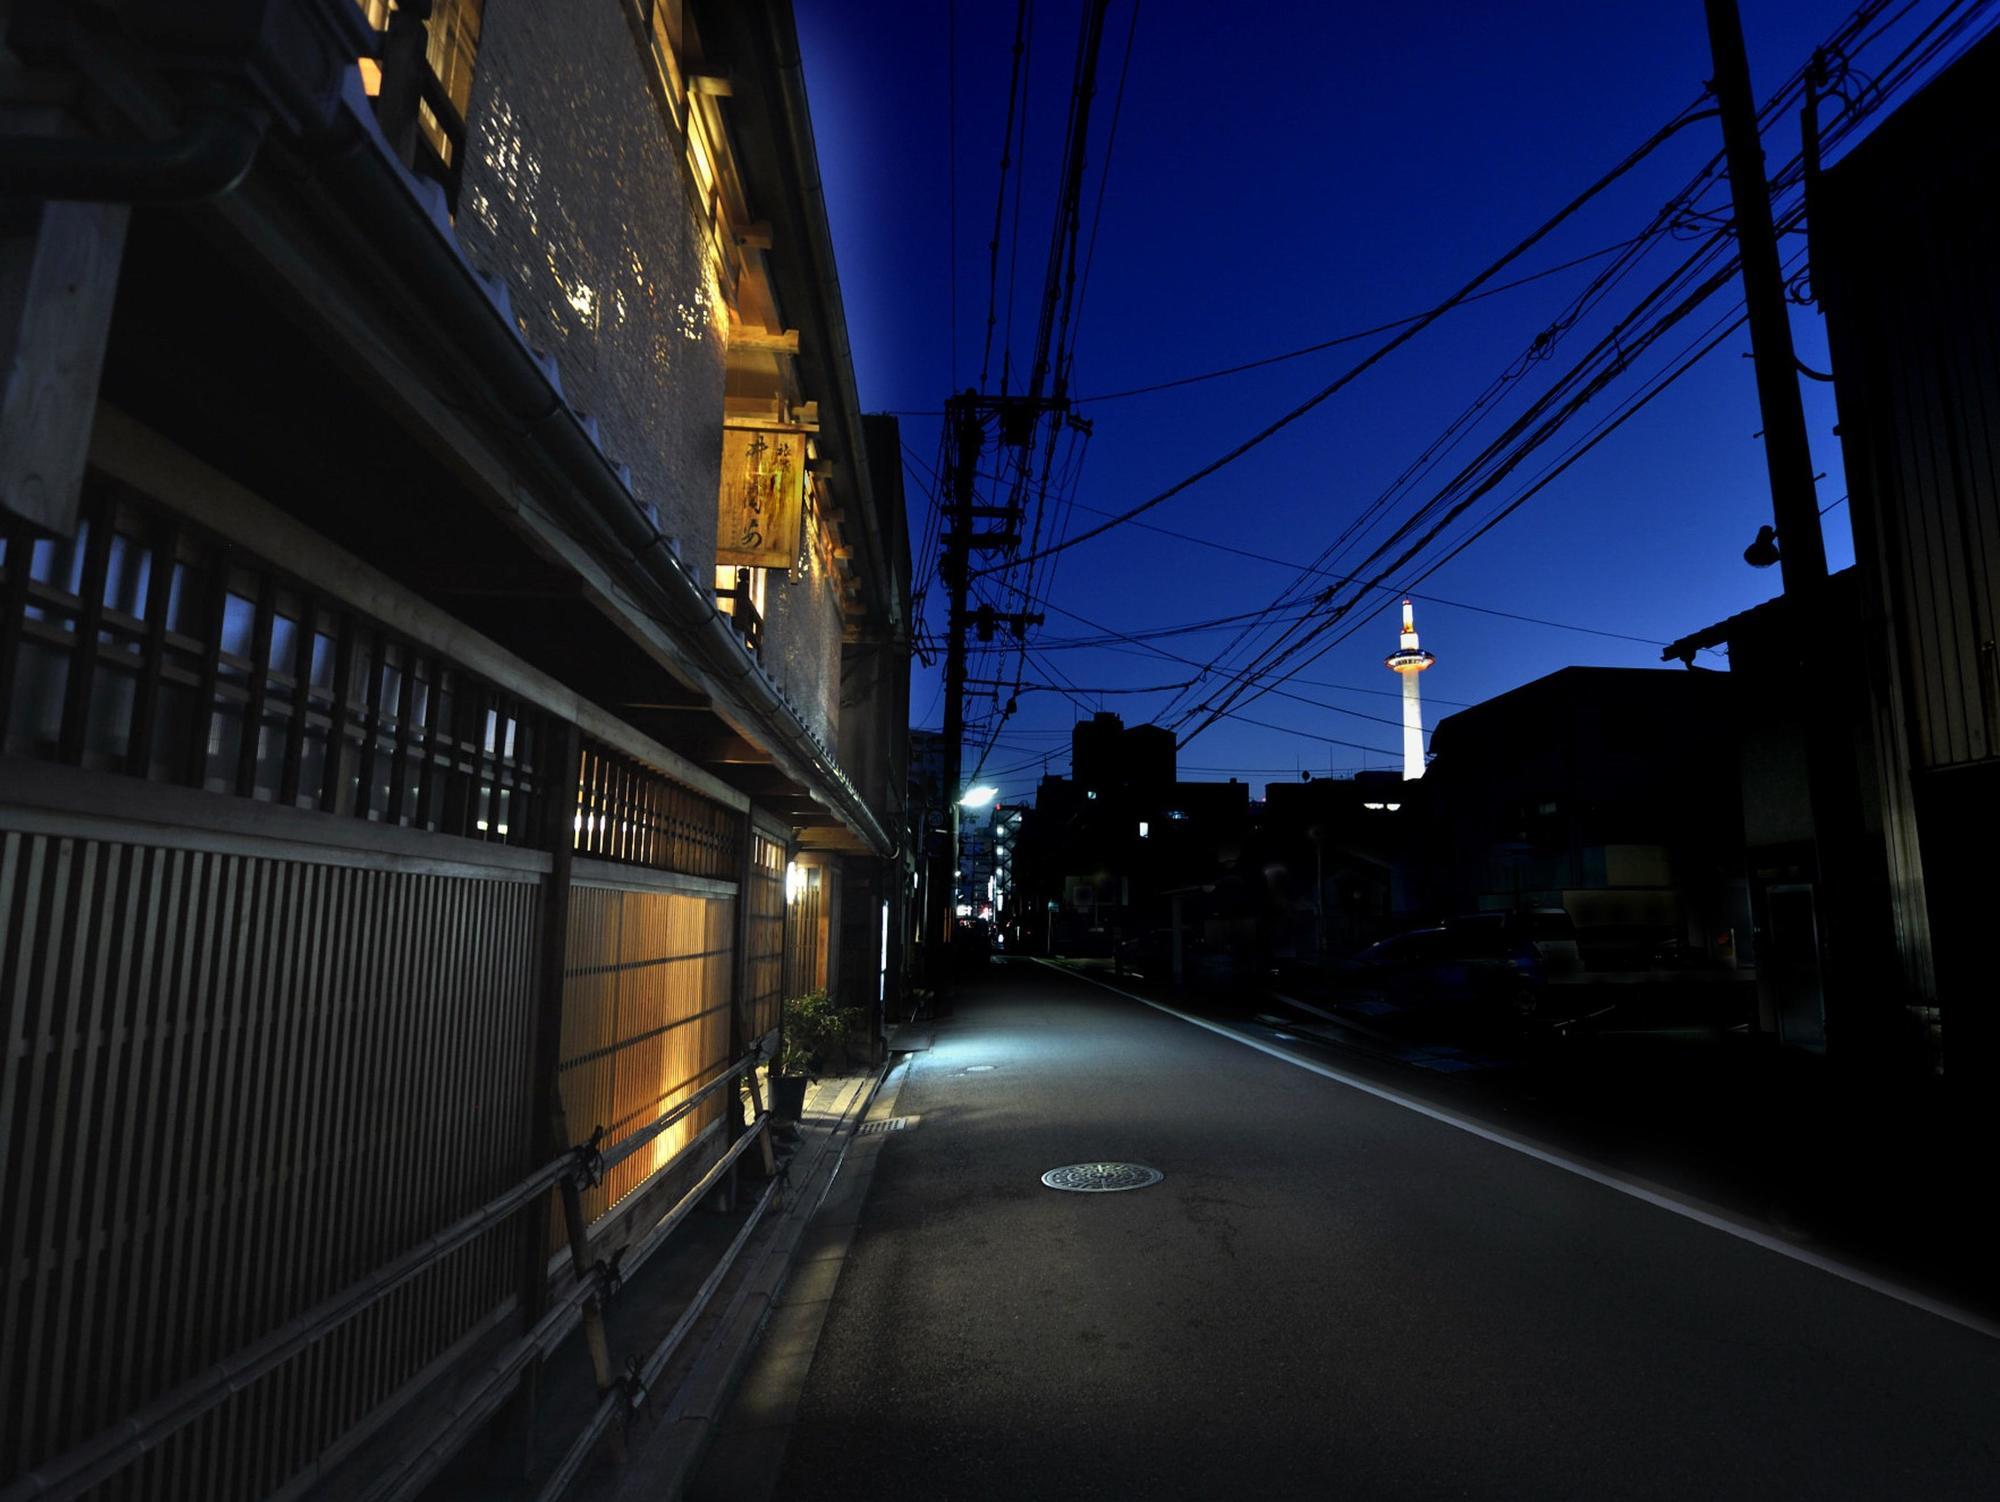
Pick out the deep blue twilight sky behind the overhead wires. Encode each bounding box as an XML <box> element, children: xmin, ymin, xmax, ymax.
<box><xmin>798</xmin><ymin>0</ymin><xmax>1976</xmax><ymax>798</ymax></box>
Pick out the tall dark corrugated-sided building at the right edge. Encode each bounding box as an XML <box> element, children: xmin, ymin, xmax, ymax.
<box><xmin>1808</xmin><ymin>38</ymin><xmax>2000</xmax><ymax>1100</ymax></box>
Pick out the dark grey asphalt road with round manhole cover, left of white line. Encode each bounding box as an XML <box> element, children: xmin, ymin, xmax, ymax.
<box><xmin>776</xmin><ymin>964</ymin><xmax>2000</xmax><ymax>1500</ymax></box>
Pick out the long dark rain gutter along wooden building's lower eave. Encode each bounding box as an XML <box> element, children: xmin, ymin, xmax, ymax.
<box><xmin>308</xmin><ymin>92</ymin><xmax>894</xmax><ymax>854</ymax></box>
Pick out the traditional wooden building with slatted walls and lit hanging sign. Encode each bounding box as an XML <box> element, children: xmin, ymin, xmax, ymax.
<box><xmin>0</xmin><ymin>0</ymin><xmax>910</xmax><ymax>1500</ymax></box>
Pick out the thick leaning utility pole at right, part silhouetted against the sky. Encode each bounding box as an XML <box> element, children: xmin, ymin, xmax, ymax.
<box><xmin>1702</xmin><ymin>0</ymin><xmax>1826</xmax><ymax>594</ymax></box>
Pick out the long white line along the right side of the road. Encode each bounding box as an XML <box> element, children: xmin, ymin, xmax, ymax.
<box><xmin>1036</xmin><ymin>960</ymin><xmax>2000</xmax><ymax>1340</ymax></box>
